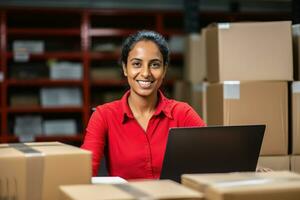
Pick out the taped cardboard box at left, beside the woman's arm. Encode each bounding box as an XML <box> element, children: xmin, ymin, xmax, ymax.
<box><xmin>0</xmin><ymin>142</ymin><xmax>92</xmax><ymax>200</ymax></box>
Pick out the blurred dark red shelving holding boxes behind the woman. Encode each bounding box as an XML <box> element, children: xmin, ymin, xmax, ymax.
<box><xmin>0</xmin><ymin>0</ymin><xmax>293</xmax><ymax>145</ymax></box>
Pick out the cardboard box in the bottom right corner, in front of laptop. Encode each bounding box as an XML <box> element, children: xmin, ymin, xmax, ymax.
<box><xmin>182</xmin><ymin>171</ymin><xmax>300</xmax><ymax>200</ymax></box>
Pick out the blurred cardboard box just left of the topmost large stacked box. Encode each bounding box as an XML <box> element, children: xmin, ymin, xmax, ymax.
<box><xmin>184</xmin><ymin>29</ymin><xmax>207</xmax><ymax>84</ymax></box>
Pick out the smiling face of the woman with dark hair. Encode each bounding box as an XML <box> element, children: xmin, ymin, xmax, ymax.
<box><xmin>123</xmin><ymin>40</ymin><xmax>167</xmax><ymax>97</ymax></box>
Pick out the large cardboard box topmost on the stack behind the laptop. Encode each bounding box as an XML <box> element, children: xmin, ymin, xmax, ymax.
<box><xmin>206</xmin><ymin>21</ymin><xmax>293</xmax><ymax>82</ymax></box>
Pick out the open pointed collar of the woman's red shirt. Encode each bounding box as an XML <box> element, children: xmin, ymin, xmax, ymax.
<box><xmin>121</xmin><ymin>90</ymin><xmax>173</xmax><ymax>123</ymax></box>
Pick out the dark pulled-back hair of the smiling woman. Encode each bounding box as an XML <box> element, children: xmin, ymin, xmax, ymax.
<box><xmin>120</xmin><ymin>30</ymin><xmax>169</xmax><ymax>66</ymax></box>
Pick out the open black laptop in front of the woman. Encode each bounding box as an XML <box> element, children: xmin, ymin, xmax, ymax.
<box><xmin>160</xmin><ymin>125</ymin><xmax>265</xmax><ymax>182</ymax></box>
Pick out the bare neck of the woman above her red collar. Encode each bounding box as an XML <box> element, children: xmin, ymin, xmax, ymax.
<box><xmin>128</xmin><ymin>91</ymin><xmax>158</xmax><ymax>117</ymax></box>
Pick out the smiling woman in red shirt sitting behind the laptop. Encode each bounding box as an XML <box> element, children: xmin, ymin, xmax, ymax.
<box><xmin>82</xmin><ymin>31</ymin><xmax>205</xmax><ymax>179</ymax></box>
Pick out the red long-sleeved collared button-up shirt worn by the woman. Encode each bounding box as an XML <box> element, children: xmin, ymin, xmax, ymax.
<box><xmin>82</xmin><ymin>91</ymin><xmax>205</xmax><ymax>179</ymax></box>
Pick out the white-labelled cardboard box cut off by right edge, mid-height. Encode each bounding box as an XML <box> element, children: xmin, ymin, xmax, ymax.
<box><xmin>291</xmin><ymin>81</ymin><xmax>300</xmax><ymax>154</ymax></box>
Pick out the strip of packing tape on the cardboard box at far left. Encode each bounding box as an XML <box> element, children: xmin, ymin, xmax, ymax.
<box><xmin>9</xmin><ymin>143</ymin><xmax>44</xmax><ymax>200</ymax></box>
